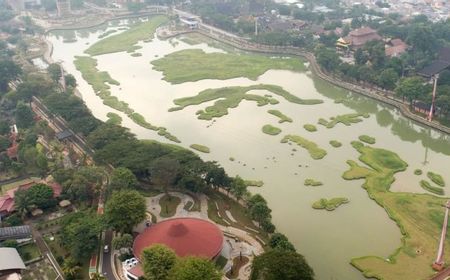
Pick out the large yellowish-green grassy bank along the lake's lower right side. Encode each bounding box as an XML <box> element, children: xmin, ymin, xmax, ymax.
<box><xmin>343</xmin><ymin>144</ymin><xmax>450</xmax><ymax>280</ymax></box>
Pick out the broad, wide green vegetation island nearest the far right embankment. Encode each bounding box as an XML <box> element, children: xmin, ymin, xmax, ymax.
<box><xmin>151</xmin><ymin>49</ymin><xmax>305</xmax><ymax>84</ymax></box>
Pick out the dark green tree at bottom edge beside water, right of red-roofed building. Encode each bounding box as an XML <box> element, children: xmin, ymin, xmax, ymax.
<box><xmin>250</xmin><ymin>250</ymin><xmax>314</xmax><ymax>280</ymax></box>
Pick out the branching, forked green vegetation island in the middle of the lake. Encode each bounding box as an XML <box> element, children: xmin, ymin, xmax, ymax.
<box><xmin>169</xmin><ymin>84</ymin><xmax>322</xmax><ymax>120</ymax></box>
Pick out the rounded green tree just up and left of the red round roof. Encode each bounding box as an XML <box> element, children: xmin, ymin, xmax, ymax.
<box><xmin>104</xmin><ymin>190</ymin><xmax>147</xmax><ymax>232</ymax></box>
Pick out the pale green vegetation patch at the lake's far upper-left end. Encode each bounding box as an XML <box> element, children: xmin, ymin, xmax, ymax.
<box><xmin>84</xmin><ymin>16</ymin><xmax>168</xmax><ymax>56</ymax></box>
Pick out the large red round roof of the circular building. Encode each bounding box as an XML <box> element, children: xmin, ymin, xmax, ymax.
<box><xmin>133</xmin><ymin>218</ymin><xmax>223</xmax><ymax>259</ymax></box>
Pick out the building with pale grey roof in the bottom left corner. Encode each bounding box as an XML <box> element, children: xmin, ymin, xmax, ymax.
<box><xmin>0</xmin><ymin>248</ymin><xmax>26</xmax><ymax>280</ymax></box>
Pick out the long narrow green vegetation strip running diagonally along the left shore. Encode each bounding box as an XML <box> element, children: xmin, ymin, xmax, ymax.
<box><xmin>74</xmin><ymin>56</ymin><xmax>180</xmax><ymax>143</ymax></box>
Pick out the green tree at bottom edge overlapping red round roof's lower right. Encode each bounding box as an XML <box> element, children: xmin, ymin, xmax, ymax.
<box><xmin>167</xmin><ymin>257</ymin><xmax>222</xmax><ymax>280</ymax></box>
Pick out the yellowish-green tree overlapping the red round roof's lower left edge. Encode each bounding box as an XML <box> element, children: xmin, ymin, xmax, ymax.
<box><xmin>141</xmin><ymin>244</ymin><xmax>177</xmax><ymax>280</ymax></box>
